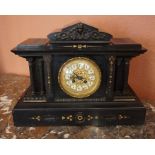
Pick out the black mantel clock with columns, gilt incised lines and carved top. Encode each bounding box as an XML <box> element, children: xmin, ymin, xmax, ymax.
<box><xmin>12</xmin><ymin>23</ymin><xmax>146</xmax><ymax>126</ymax></box>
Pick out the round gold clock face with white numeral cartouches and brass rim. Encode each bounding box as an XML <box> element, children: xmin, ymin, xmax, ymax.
<box><xmin>58</xmin><ymin>57</ymin><xmax>101</xmax><ymax>98</ymax></box>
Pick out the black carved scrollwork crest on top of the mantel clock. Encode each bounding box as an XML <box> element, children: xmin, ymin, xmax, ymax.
<box><xmin>48</xmin><ymin>23</ymin><xmax>112</xmax><ymax>42</ymax></box>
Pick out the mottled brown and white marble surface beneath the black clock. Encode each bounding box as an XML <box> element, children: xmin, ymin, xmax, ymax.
<box><xmin>0</xmin><ymin>75</ymin><xmax>155</xmax><ymax>139</ymax></box>
